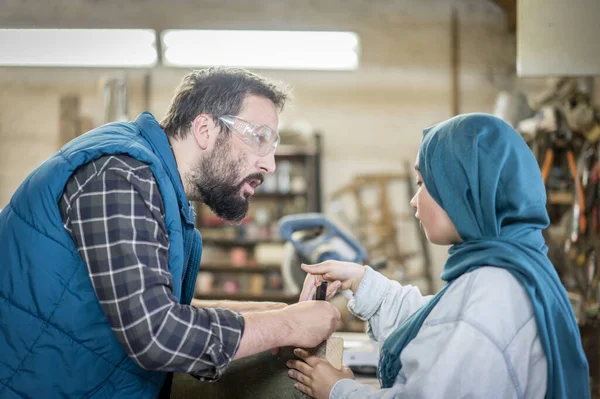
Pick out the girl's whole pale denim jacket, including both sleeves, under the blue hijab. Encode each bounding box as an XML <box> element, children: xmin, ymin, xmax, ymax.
<box><xmin>329</xmin><ymin>267</ymin><xmax>547</xmax><ymax>399</ymax></box>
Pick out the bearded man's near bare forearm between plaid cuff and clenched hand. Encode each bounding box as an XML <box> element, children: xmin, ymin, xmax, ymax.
<box><xmin>233</xmin><ymin>310</ymin><xmax>293</xmax><ymax>359</ymax></box>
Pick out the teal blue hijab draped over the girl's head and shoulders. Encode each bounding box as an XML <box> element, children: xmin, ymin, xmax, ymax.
<box><xmin>378</xmin><ymin>114</ymin><xmax>590</xmax><ymax>399</ymax></box>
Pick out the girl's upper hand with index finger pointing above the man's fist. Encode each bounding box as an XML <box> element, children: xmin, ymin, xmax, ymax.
<box><xmin>300</xmin><ymin>260</ymin><xmax>365</xmax><ymax>301</ymax></box>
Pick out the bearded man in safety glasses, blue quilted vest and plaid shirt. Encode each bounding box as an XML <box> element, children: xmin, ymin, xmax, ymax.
<box><xmin>0</xmin><ymin>68</ymin><xmax>340</xmax><ymax>398</ymax></box>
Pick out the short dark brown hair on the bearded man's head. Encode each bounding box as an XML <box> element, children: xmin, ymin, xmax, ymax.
<box><xmin>160</xmin><ymin>67</ymin><xmax>289</xmax><ymax>139</ymax></box>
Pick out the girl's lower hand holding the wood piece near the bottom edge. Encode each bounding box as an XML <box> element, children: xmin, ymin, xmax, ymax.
<box><xmin>286</xmin><ymin>349</ymin><xmax>354</xmax><ymax>399</ymax></box>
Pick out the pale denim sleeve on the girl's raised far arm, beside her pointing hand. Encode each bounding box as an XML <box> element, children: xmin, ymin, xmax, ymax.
<box><xmin>348</xmin><ymin>266</ymin><xmax>433</xmax><ymax>343</ymax></box>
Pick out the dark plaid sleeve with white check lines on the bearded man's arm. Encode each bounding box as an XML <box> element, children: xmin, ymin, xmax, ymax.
<box><xmin>59</xmin><ymin>155</ymin><xmax>244</xmax><ymax>380</ymax></box>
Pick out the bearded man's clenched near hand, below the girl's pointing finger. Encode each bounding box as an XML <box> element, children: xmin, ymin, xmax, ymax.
<box><xmin>280</xmin><ymin>301</ymin><xmax>340</xmax><ymax>348</ymax></box>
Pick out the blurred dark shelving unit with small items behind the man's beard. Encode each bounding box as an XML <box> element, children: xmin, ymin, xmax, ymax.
<box><xmin>195</xmin><ymin>132</ymin><xmax>321</xmax><ymax>303</ymax></box>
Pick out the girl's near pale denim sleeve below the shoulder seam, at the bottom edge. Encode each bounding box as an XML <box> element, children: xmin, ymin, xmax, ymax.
<box><xmin>329</xmin><ymin>321</ymin><xmax>518</xmax><ymax>399</ymax></box>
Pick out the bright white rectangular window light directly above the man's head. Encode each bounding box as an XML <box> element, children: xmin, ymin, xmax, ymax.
<box><xmin>162</xmin><ymin>30</ymin><xmax>359</xmax><ymax>70</ymax></box>
